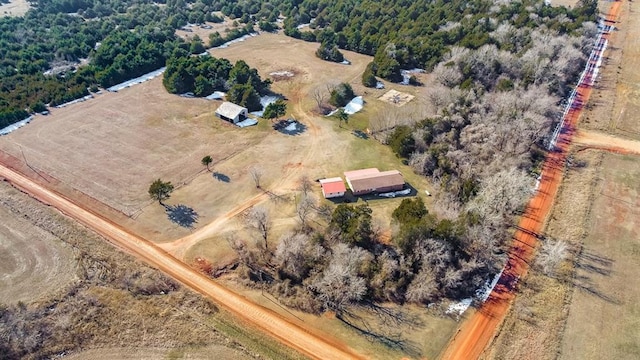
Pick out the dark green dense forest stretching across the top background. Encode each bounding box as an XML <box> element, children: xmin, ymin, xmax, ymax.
<box><xmin>0</xmin><ymin>0</ymin><xmax>596</xmax><ymax>126</ymax></box>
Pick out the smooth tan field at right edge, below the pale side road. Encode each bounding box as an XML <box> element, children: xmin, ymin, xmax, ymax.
<box><xmin>560</xmin><ymin>154</ymin><xmax>640</xmax><ymax>359</ymax></box>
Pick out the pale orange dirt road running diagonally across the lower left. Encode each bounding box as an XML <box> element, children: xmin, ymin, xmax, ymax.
<box><xmin>0</xmin><ymin>165</ymin><xmax>363</xmax><ymax>359</ymax></box>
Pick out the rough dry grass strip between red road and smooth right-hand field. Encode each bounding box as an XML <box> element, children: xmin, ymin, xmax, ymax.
<box><xmin>486</xmin><ymin>150</ymin><xmax>602</xmax><ymax>360</ymax></box>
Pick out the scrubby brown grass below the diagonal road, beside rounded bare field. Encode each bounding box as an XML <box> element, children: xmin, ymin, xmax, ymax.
<box><xmin>0</xmin><ymin>184</ymin><xmax>298</xmax><ymax>359</ymax></box>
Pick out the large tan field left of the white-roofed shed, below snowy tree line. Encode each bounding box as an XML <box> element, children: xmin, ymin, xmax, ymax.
<box><xmin>0</xmin><ymin>78</ymin><xmax>260</xmax><ymax>215</ymax></box>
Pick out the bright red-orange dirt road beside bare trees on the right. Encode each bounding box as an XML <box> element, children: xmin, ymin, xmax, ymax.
<box><xmin>440</xmin><ymin>1</ymin><xmax>621</xmax><ymax>360</ymax></box>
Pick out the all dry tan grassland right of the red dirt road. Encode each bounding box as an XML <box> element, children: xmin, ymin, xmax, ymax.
<box><xmin>485</xmin><ymin>2</ymin><xmax>640</xmax><ymax>359</ymax></box>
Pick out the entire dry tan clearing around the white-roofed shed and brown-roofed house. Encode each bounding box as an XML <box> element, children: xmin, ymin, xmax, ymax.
<box><xmin>0</xmin><ymin>34</ymin><xmax>436</xmax><ymax>248</ymax></box>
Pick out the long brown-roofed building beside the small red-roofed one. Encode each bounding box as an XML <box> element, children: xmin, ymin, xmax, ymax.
<box><xmin>344</xmin><ymin>168</ymin><xmax>405</xmax><ymax>195</ymax></box>
